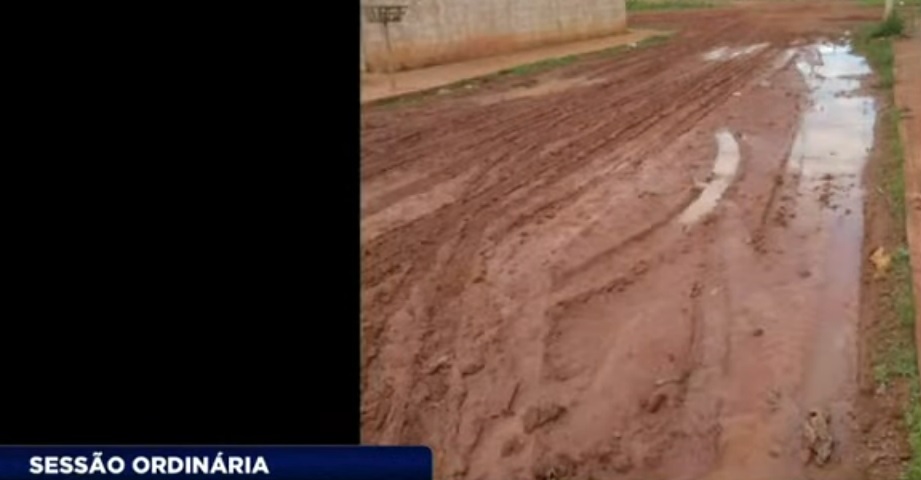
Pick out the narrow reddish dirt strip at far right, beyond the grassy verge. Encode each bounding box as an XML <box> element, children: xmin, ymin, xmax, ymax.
<box><xmin>895</xmin><ymin>33</ymin><xmax>921</xmax><ymax>380</ymax></box>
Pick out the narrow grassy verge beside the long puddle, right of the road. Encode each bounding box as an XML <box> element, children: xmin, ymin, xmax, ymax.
<box><xmin>854</xmin><ymin>20</ymin><xmax>921</xmax><ymax>480</ymax></box>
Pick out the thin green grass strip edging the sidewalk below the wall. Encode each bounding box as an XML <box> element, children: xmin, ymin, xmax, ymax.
<box><xmin>367</xmin><ymin>33</ymin><xmax>672</xmax><ymax>107</ymax></box>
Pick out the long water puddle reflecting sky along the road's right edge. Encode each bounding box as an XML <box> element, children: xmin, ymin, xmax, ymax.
<box><xmin>789</xmin><ymin>43</ymin><xmax>876</xmax><ymax>413</ymax></box>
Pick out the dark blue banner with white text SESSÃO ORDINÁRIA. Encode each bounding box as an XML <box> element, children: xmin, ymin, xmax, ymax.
<box><xmin>0</xmin><ymin>446</ymin><xmax>433</xmax><ymax>480</ymax></box>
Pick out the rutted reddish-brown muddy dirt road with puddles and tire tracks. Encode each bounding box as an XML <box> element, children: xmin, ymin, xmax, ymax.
<box><xmin>362</xmin><ymin>3</ymin><xmax>892</xmax><ymax>480</ymax></box>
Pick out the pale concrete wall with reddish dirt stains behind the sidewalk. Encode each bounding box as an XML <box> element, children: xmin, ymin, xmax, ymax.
<box><xmin>361</xmin><ymin>0</ymin><xmax>627</xmax><ymax>72</ymax></box>
